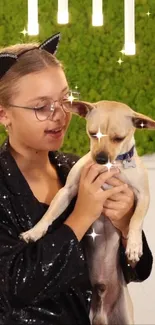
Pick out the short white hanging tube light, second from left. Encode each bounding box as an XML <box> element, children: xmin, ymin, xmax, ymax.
<box><xmin>57</xmin><ymin>0</ymin><xmax>69</xmax><ymax>24</ymax></box>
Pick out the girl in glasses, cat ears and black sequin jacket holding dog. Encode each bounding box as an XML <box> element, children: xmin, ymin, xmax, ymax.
<box><xmin>0</xmin><ymin>35</ymin><xmax>152</xmax><ymax>325</ymax></box>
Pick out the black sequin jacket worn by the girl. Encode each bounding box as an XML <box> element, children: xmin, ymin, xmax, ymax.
<box><xmin>0</xmin><ymin>140</ymin><xmax>152</xmax><ymax>325</ymax></box>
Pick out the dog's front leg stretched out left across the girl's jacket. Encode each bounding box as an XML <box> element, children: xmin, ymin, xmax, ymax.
<box><xmin>19</xmin><ymin>152</ymin><xmax>91</xmax><ymax>242</ymax></box>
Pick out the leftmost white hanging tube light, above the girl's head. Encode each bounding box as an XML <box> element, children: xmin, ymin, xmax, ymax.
<box><xmin>27</xmin><ymin>0</ymin><xmax>39</xmax><ymax>35</ymax></box>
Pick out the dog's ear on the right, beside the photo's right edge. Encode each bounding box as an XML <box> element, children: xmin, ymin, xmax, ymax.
<box><xmin>132</xmin><ymin>112</ymin><xmax>155</xmax><ymax>129</ymax></box>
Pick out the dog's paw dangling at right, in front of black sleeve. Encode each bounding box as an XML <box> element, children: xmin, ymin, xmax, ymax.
<box><xmin>126</xmin><ymin>230</ymin><xmax>143</xmax><ymax>263</ymax></box>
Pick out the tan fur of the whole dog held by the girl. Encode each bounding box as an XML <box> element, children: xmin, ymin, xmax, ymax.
<box><xmin>20</xmin><ymin>101</ymin><xmax>155</xmax><ymax>325</ymax></box>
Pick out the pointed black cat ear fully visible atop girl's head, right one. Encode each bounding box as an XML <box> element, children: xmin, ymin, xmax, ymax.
<box><xmin>39</xmin><ymin>33</ymin><xmax>61</xmax><ymax>55</ymax></box>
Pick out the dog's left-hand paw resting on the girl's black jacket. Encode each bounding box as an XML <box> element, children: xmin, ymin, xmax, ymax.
<box><xmin>19</xmin><ymin>225</ymin><xmax>48</xmax><ymax>243</ymax></box>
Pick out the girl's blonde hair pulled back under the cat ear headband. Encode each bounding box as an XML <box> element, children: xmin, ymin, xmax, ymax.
<box><xmin>0</xmin><ymin>43</ymin><xmax>63</xmax><ymax>107</ymax></box>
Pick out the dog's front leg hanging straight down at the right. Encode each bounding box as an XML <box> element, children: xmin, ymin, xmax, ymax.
<box><xmin>126</xmin><ymin>190</ymin><xmax>149</xmax><ymax>262</ymax></box>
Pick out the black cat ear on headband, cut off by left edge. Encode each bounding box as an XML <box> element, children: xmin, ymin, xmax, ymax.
<box><xmin>0</xmin><ymin>53</ymin><xmax>17</xmax><ymax>78</ymax></box>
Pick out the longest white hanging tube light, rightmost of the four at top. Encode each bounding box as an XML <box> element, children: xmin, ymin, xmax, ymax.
<box><xmin>124</xmin><ymin>0</ymin><xmax>136</xmax><ymax>55</ymax></box>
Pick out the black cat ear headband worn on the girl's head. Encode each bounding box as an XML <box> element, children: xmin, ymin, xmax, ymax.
<box><xmin>0</xmin><ymin>33</ymin><xmax>61</xmax><ymax>78</ymax></box>
